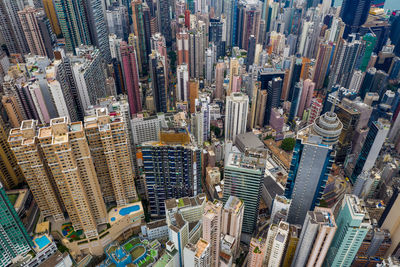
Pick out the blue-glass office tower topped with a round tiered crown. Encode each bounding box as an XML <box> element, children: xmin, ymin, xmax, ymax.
<box><xmin>285</xmin><ymin>112</ymin><xmax>343</xmax><ymax>225</ymax></box>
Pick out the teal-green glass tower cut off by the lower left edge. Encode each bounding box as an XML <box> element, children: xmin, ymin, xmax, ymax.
<box><xmin>0</xmin><ymin>183</ymin><xmax>34</xmax><ymax>266</ymax></box>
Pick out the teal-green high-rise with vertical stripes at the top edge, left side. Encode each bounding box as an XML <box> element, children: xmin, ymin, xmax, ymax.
<box><xmin>54</xmin><ymin>0</ymin><xmax>91</xmax><ymax>53</ymax></box>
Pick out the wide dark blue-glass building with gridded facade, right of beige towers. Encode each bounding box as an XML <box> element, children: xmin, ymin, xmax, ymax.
<box><xmin>142</xmin><ymin>138</ymin><xmax>201</xmax><ymax>217</ymax></box>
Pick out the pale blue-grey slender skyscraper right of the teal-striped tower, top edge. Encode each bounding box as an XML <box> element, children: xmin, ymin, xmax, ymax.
<box><xmin>85</xmin><ymin>0</ymin><xmax>111</xmax><ymax>63</ymax></box>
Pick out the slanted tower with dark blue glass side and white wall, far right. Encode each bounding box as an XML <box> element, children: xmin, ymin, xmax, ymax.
<box><xmin>350</xmin><ymin>118</ymin><xmax>390</xmax><ymax>184</ymax></box>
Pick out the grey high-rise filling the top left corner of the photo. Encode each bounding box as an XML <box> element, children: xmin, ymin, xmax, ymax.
<box><xmin>0</xmin><ymin>0</ymin><xmax>29</xmax><ymax>54</ymax></box>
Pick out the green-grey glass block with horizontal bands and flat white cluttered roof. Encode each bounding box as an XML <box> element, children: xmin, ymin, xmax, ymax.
<box><xmin>223</xmin><ymin>151</ymin><xmax>266</xmax><ymax>234</ymax></box>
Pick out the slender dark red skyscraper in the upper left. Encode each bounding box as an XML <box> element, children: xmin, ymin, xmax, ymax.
<box><xmin>120</xmin><ymin>41</ymin><xmax>142</xmax><ymax>114</ymax></box>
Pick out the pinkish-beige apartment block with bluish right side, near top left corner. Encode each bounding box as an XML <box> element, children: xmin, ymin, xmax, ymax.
<box><xmin>18</xmin><ymin>6</ymin><xmax>56</xmax><ymax>58</ymax></box>
